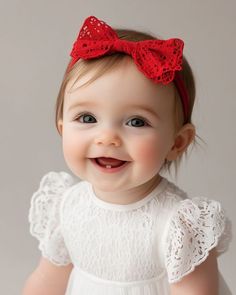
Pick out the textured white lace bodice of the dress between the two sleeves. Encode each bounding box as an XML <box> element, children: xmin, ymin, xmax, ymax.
<box><xmin>62</xmin><ymin>182</ymin><xmax>168</xmax><ymax>282</ymax></box>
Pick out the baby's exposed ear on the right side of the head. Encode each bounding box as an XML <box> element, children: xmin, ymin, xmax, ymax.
<box><xmin>166</xmin><ymin>123</ymin><xmax>196</xmax><ymax>161</ymax></box>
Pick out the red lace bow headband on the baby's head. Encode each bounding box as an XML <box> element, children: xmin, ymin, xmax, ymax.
<box><xmin>67</xmin><ymin>16</ymin><xmax>189</xmax><ymax>122</ymax></box>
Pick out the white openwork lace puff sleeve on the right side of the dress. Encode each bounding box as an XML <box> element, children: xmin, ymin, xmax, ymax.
<box><xmin>165</xmin><ymin>198</ymin><xmax>231</xmax><ymax>283</ymax></box>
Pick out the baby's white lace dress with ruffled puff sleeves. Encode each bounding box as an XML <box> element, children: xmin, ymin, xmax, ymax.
<box><xmin>29</xmin><ymin>172</ymin><xmax>231</xmax><ymax>295</ymax></box>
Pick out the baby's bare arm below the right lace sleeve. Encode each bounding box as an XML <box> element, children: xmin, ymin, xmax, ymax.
<box><xmin>170</xmin><ymin>248</ymin><xmax>218</xmax><ymax>295</ymax></box>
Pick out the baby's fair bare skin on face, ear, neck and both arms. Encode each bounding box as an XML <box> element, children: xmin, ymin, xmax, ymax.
<box><xmin>23</xmin><ymin>57</ymin><xmax>218</xmax><ymax>295</ymax></box>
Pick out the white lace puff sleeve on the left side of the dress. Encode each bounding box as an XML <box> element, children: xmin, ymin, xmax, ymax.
<box><xmin>28</xmin><ymin>172</ymin><xmax>74</xmax><ymax>265</ymax></box>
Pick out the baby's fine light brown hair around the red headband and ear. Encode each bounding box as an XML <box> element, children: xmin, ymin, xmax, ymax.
<box><xmin>55</xmin><ymin>29</ymin><xmax>200</xmax><ymax>174</ymax></box>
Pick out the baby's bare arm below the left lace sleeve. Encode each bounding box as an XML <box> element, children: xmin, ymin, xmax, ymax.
<box><xmin>22</xmin><ymin>257</ymin><xmax>73</xmax><ymax>295</ymax></box>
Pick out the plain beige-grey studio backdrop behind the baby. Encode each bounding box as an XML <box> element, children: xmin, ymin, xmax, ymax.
<box><xmin>0</xmin><ymin>0</ymin><xmax>236</xmax><ymax>295</ymax></box>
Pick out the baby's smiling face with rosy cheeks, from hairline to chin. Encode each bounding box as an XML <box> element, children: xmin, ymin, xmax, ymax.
<box><xmin>59</xmin><ymin>57</ymin><xmax>177</xmax><ymax>200</ymax></box>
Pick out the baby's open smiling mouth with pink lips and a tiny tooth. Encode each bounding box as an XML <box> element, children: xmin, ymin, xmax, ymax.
<box><xmin>90</xmin><ymin>157</ymin><xmax>129</xmax><ymax>173</ymax></box>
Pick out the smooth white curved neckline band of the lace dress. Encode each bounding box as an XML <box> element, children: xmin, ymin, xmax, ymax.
<box><xmin>87</xmin><ymin>177</ymin><xmax>168</xmax><ymax>211</ymax></box>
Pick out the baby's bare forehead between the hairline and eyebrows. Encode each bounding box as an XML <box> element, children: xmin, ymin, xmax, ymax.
<box><xmin>64</xmin><ymin>57</ymin><xmax>174</xmax><ymax>111</ymax></box>
